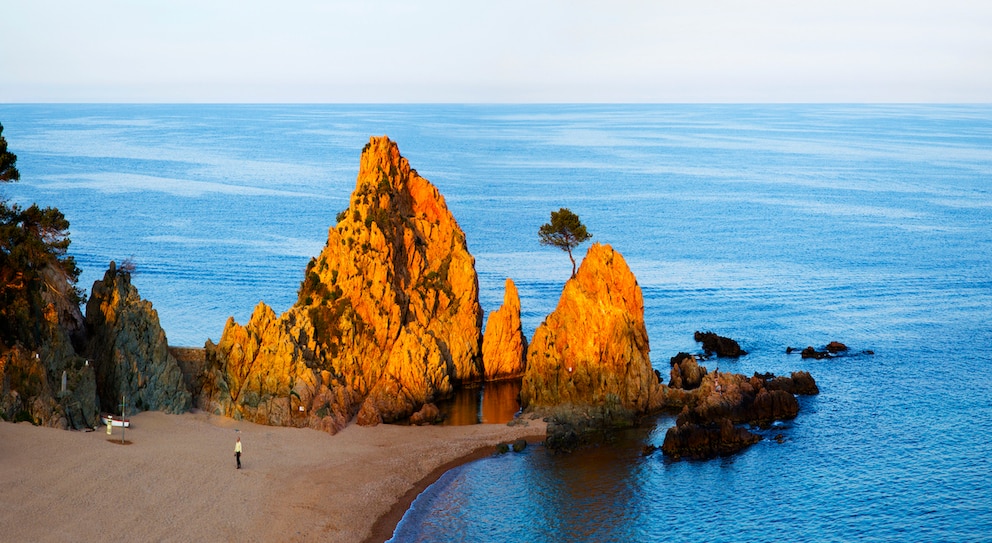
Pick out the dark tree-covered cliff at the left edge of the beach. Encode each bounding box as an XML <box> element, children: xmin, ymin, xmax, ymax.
<box><xmin>0</xmin><ymin>121</ymin><xmax>96</xmax><ymax>428</ymax></box>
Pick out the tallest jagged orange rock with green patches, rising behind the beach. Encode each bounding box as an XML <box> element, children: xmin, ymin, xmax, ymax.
<box><xmin>200</xmin><ymin>137</ymin><xmax>484</xmax><ymax>431</ymax></box>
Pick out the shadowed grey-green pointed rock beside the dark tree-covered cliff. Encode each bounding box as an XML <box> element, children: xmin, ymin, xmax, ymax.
<box><xmin>86</xmin><ymin>262</ymin><xmax>192</xmax><ymax>413</ymax></box>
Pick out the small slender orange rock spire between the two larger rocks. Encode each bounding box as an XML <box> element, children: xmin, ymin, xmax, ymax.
<box><xmin>482</xmin><ymin>279</ymin><xmax>527</xmax><ymax>381</ymax></box>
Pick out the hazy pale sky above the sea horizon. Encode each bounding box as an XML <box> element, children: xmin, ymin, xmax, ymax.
<box><xmin>0</xmin><ymin>0</ymin><xmax>992</xmax><ymax>103</ymax></box>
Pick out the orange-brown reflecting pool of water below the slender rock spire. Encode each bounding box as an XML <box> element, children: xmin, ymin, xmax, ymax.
<box><xmin>438</xmin><ymin>379</ymin><xmax>520</xmax><ymax>426</ymax></box>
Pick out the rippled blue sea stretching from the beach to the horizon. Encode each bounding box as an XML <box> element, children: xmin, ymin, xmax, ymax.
<box><xmin>0</xmin><ymin>104</ymin><xmax>992</xmax><ymax>542</ymax></box>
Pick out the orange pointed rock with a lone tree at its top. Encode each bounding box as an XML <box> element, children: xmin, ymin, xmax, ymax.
<box><xmin>520</xmin><ymin>243</ymin><xmax>661</xmax><ymax>412</ymax></box>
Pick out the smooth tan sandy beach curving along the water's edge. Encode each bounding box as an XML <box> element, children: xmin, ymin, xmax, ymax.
<box><xmin>0</xmin><ymin>412</ymin><xmax>545</xmax><ymax>542</ymax></box>
